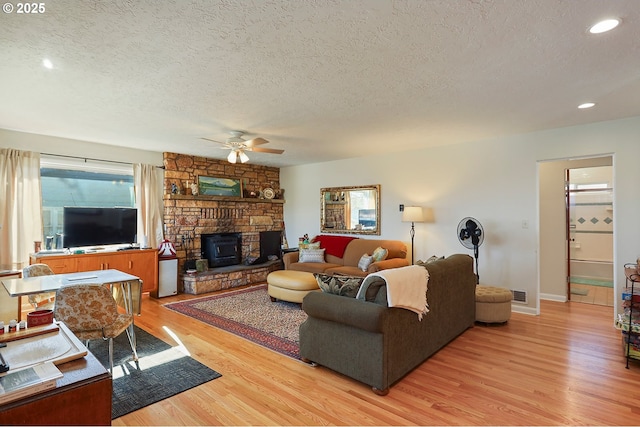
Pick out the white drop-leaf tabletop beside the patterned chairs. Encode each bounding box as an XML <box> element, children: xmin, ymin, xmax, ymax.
<box><xmin>2</xmin><ymin>270</ymin><xmax>139</xmax><ymax>297</ymax></box>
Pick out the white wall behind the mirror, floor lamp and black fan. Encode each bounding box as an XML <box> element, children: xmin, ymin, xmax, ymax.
<box><xmin>280</xmin><ymin>117</ymin><xmax>640</xmax><ymax>313</ymax></box>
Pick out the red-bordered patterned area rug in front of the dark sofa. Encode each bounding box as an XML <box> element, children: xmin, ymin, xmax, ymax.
<box><xmin>165</xmin><ymin>285</ymin><xmax>307</xmax><ymax>359</ymax></box>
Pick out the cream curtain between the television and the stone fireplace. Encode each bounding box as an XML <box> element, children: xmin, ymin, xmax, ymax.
<box><xmin>133</xmin><ymin>163</ymin><xmax>164</xmax><ymax>248</ymax></box>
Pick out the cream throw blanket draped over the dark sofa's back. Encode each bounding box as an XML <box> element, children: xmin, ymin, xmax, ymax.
<box><xmin>356</xmin><ymin>265</ymin><xmax>429</xmax><ymax>320</ymax></box>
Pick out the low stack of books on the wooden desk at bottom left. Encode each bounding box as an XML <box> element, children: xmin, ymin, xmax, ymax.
<box><xmin>0</xmin><ymin>362</ymin><xmax>62</xmax><ymax>405</ymax></box>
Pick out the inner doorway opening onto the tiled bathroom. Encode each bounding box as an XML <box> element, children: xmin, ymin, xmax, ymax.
<box><xmin>565</xmin><ymin>166</ymin><xmax>614</xmax><ymax>307</ymax></box>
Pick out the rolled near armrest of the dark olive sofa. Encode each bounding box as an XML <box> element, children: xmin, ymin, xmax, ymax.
<box><xmin>302</xmin><ymin>292</ymin><xmax>389</xmax><ymax>332</ymax></box>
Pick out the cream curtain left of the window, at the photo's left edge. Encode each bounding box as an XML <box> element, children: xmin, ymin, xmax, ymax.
<box><xmin>0</xmin><ymin>148</ymin><xmax>43</xmax><ymax>269</ymax></box>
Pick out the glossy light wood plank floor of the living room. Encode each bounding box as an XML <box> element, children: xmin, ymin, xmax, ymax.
<box><xmin>113</xmin><ymin>295</ymin><xmax>640</xmax><ymax>425</ymax></box>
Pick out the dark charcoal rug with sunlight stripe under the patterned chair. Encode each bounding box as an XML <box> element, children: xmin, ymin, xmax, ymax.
<box><xmin>89</xmin><ymin>326</ymin><xmax>221</xmax><ymax>419</ymax></box>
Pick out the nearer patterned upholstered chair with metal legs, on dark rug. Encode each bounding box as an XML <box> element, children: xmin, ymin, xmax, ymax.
<box><xmin>54</xmin><ymin>284</ymin><xmax>135</xmax><ymax>372</ymax></box>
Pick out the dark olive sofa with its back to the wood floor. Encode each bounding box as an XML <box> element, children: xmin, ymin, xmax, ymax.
<box><xmin>300</xmin><ymin>254</ymin><xmax>476</xmax><ymax>395</ymax></box>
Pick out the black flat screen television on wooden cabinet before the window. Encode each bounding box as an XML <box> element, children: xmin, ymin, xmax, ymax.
<box><xmin>63</xmin><ymin>207</ymin><xmax>138</xmax><ymax>248</ymax></box>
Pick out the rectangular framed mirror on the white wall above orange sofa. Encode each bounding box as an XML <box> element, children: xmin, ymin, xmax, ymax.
<box><xmin>320</xmin><ymin>185</ymin><xmax>380</xmax><ymax>235</ymax></box>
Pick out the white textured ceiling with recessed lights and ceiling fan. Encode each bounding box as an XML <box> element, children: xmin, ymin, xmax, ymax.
<box><xmin>0</xmin><ymin>0</ymin><xmax>640</xmax><ymax>166</ymax></box>
